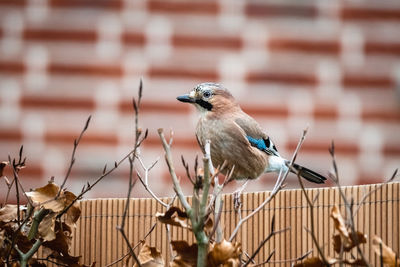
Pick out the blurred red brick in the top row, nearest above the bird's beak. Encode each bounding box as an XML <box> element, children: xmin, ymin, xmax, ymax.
<box><xmin>147</xmin><ymin>0</ymin><xmax>219</xmax><ymax>15</ymax></box>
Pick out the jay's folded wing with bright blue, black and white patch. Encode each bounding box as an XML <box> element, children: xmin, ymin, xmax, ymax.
<box><xmin>235</xmin><ymin>114</ymin><xmax>280</xmax><ymax>157</ymax></box>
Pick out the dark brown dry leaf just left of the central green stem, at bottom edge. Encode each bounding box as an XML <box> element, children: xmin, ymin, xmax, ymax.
<box><xmin>171</xmin><ymin>241</ymin><xmax>197</xmax><ymax>267</ymax></box>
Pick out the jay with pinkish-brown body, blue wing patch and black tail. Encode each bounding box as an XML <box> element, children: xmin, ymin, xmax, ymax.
<box><xmin>177</xmin><ymin>82</ymin><xmax>326</xmax><ymax>184</ymax></box>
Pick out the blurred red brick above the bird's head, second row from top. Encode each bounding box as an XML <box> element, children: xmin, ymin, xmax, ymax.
<box><xmin>172</xmin><ymin>34</ymin><xmax>243</xmax><ymax>50</ymax></box>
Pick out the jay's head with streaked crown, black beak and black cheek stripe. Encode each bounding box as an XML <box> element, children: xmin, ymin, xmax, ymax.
<box><xmin>176</xmin><ymin>82</ymin><xmax>238</xmax><ymax>113</ymax></box>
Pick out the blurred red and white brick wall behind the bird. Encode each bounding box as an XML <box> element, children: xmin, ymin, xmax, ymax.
<box><xmin>0</xmin><ymin>0</ymin><xmax>400</xmax><ymax>201</ymax></box>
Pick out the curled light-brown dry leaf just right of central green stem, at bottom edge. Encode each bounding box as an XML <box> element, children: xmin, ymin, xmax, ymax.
<box><xmin>207</xmin><ymin>239</ymin><xmax>242</xmax><ymax>266</ymax></box>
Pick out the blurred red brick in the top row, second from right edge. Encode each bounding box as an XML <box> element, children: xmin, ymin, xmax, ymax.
<box><xmin>245</xmin><ymin>3</ymin><xmax>318</xmax><ymax>18</ymax></box>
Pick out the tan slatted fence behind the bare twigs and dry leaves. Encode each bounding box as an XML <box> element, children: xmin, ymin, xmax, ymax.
<box><xmin>69</xmin><ymin>182</ymin><xmax>400</xmax><ymax>266</ymax></box>
